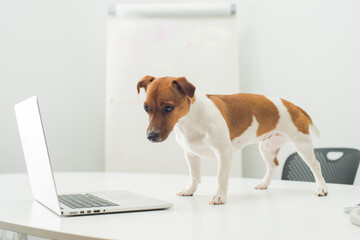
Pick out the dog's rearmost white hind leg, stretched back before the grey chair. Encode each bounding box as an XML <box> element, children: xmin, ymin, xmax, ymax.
<box><xmin>290</xmin><ymin>134</ymin><xmax>328</xmax><ymax>197</ymax></box>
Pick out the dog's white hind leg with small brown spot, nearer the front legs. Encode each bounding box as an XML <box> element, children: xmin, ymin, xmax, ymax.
<box><xmin>255</xmin><ymin>134</ymin><xmax>287</xmax><ymax>189</ymax></box>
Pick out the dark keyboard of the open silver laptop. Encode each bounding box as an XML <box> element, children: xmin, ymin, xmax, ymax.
<box><xmin>59</xmin><ymin>193</ymin><xmax>119</xmax><ymax>209</ymax></box>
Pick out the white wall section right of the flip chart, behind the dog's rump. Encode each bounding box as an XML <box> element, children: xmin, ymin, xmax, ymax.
<box><xmin>238</xmin><ymin>0</ymin><xmax>360</xmax><ymax>178</ymax></box>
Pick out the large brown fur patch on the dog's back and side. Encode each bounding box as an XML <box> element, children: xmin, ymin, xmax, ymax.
<box><xmin>207</xmin><ymin>93</ymin><xmax>280</xmax><ymax>140</ymax></box>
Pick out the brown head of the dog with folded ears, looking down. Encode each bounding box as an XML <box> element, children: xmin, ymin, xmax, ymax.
<box><xmin>137</xmin><ymin>76</ymin><xmax>195</xmax><ymax>143</ymax></box>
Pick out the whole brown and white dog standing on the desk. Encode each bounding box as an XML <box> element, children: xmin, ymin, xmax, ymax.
<box><xmin>137</xmin><ymin>76</ymin><xmax>327</xmax><ymax>204</ymax></box>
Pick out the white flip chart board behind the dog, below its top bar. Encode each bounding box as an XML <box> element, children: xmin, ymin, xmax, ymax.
<box><xmin>105</xmin><ymin>3</ymin><xmax>241</xmax><ymax>176</ymax></box>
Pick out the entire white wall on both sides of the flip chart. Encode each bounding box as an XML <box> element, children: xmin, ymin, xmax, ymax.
<box><xmin>0</xmin><ymin>0</ymin><xmax>360</xmax><ymax>180</ymax></box>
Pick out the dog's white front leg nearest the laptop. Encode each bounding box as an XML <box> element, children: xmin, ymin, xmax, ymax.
<box><xmin>177</xmin><ymin>152</ymin><xmax>201</xmax><ymax>196</ymax></box>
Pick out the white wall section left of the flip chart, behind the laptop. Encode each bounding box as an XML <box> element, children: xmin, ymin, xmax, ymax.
<box><xmin>0</xmin><ymin>0</ymin><xmax>106</xmax><ymax>173</ymax></box>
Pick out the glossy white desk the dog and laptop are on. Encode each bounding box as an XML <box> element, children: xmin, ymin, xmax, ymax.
<box><xmin>0</xmin><ymin>173</ymin><xmax>360</xmax><ymax>240</ymax></box>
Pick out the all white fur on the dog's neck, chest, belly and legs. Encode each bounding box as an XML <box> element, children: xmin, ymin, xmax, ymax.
<box><xmin>174</xmin><ymin>92</ymin><xmax>327</xmax><ymax>204</ymax></box>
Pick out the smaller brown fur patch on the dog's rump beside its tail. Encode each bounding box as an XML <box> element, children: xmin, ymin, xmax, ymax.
<box><xmin>281</xmin><ymin>99</ymin><xmax>312</xmax><ymax>134</ymax></box>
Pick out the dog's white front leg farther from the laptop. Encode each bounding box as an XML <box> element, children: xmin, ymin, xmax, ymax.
<box><xmin>209</xmin><ymin>149</ymin><xmax>233</xmax><ymax>205</ymax></box>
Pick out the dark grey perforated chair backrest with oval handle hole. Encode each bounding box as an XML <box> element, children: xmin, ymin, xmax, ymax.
<box><xmin>281</xmin><ymin>148</ymin><xmax>360</xmax><ymax>184</ymax></box>
